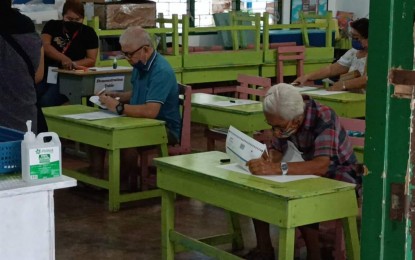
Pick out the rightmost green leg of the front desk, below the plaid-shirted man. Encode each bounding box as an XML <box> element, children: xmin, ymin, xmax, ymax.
<box><xmin>342</xmin><ymin>217</ymin><xmax>360</xmax><ymax>260</ymax></box>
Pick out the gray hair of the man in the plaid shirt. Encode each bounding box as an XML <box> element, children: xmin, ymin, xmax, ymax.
<box><xmin>264</xmin><ymin>83</ymin><xmax>304</xmax><ymax>120</ymax></box>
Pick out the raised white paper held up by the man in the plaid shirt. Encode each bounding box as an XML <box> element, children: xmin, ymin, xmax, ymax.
<box><xmin>226</xmin><ymin>126</ymin><xmax>266</xmax><ymax>172</ymax></box>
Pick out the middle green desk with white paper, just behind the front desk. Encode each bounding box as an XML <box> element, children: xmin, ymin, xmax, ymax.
<box><xmin>192</xmin><ymin>93</ymin><xmax>270</xmax><ymax>136</ymax></box>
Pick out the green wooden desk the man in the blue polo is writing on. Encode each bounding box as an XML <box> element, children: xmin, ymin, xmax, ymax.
<box><xmin>43</xmin><ymin>105</ymin><xmax>168</xmax><ymax>211</ymax></box>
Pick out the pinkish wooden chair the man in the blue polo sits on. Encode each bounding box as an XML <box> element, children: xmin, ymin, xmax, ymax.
<box><xmin>140</xmin><ymin>83</ymin><xmax>192</xmax><ymax>190</ymax></box>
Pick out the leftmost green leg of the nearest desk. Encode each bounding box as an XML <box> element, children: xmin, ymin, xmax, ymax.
<box><xmin>161</xmin><ymin>190</ymin><xmax>175</xmax><ymax>260</ymax></box>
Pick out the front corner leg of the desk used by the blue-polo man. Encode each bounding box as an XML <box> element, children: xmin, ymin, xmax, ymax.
<box><xmin>108</xmin><ymin>149</ymin><xmax>120</xmax><ymax>211</ymax></box>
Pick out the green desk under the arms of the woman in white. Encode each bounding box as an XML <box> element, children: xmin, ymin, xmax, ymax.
<box><xmin>302</xmin><ymin>91</ymin><xmax>366</xmax><ymax>118</ymax></box>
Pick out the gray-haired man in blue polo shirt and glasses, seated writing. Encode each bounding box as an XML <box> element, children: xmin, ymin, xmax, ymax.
<box><xmin>96</xmin><ymin>26</ymin><xmax>181</xmax><ymax>189</ymax></box>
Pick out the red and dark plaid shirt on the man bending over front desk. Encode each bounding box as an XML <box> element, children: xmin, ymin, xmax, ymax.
<box><xmin>272</xmin><ymin>95</ymin><xmax>357</xmax><ymax>183</ymax></box>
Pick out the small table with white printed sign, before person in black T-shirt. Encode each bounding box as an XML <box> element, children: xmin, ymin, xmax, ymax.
<box><xmin>56</xmin><ymin>68</ymin><xmax>133</xmax><ymax>105</ymax></box>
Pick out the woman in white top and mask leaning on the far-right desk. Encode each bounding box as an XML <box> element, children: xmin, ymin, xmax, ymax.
<box><xmin>293</xmin><ymin>18</ymin><xmax>369</xmax><ymax>92</ymax></box>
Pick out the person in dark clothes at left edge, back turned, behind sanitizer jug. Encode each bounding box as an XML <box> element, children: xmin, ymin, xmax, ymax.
<box><xmin>0</xmin><ymin>0</ymin><xmax>44</xmax><ymax>133</ymax></box>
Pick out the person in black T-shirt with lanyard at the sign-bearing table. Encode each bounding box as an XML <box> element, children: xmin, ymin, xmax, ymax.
<box><xmin>38</xmin><ymin>0</ymin><xmax>98</xmax><ymax>107</ymax></box>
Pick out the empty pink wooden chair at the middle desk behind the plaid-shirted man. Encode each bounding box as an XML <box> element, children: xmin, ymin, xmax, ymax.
<box><xmin>205</xmin><ymin>74</ymin><xmax>272</xmax><ymax>151</ymax></box>
